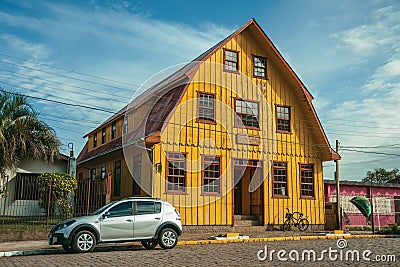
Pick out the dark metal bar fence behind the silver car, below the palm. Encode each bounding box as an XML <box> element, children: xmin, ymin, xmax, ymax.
<box><xmin>0</xmin><ymin>173</ymin><xmax>111</xmax><ymax>241</ymax></box>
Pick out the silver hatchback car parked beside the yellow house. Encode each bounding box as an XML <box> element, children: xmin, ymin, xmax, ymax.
<box><xmin>48</xmin><ymin>197</ymin><xmax>182</xmax><ymax>253</ymax></box>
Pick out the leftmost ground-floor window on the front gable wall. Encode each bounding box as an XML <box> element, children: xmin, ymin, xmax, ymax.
<box><xmin>167</xmin><ymin>153</ymin><xmax>186</xmax><ymax>192</ymax></box>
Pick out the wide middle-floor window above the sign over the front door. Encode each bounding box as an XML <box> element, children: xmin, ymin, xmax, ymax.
<box><xmin>235</xmin><ymin>99</ymin><xmax>260</xmax><ymax>129</ymax></box>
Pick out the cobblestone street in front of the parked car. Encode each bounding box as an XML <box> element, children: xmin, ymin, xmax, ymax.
<box><xmin>0</xmin><ymin>238</ymin><xmax>400</xmax><ymax>267</ymax></box>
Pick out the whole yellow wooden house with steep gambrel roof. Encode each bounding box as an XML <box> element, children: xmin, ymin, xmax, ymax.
<box><xmin>77</xmin><ymin>19</ymin><xmax>340</xmax><ymax>227</ymax></box>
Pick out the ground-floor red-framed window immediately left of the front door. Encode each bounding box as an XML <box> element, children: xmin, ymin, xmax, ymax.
<box><xmin>203</xmin><ymin>156</ymin><xmax>221</xmax><ymax>195</ymax></box>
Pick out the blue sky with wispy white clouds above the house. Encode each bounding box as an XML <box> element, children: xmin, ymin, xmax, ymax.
<box><xmin>0</xmin><ymin>0</ymin><xmax>400</xmax><ymax>180</ymax></box>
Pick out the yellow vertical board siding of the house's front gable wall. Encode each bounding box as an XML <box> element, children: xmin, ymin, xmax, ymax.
<box><xmin>153</xmin><ymin>25</ymin><xmax>324</xmax><ymax>225</ymax></box>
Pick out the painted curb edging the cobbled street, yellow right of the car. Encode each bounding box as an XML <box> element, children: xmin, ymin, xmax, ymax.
<box><xmin>0</xmin><ymin>235</ymin><xmax>400</xmax><ymax>257</ymax></box>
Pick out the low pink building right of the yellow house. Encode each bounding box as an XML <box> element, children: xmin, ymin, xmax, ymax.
<box><xmin>324</xmin><ymin>180</ymin><xmax>400</xmax><ymax>229</ymax></box>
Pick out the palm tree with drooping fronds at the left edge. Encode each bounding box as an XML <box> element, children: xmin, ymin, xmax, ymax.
<box><xmin>0</xmin><ymin>91</ymin><xmax>60</xmax><ymax>174</ymax></box>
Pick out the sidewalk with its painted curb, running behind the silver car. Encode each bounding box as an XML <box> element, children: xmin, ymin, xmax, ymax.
<box><xmin>0</xmin><ymin>231</ymin><xmax>390</xmax><ymax>257</ymax></box>
